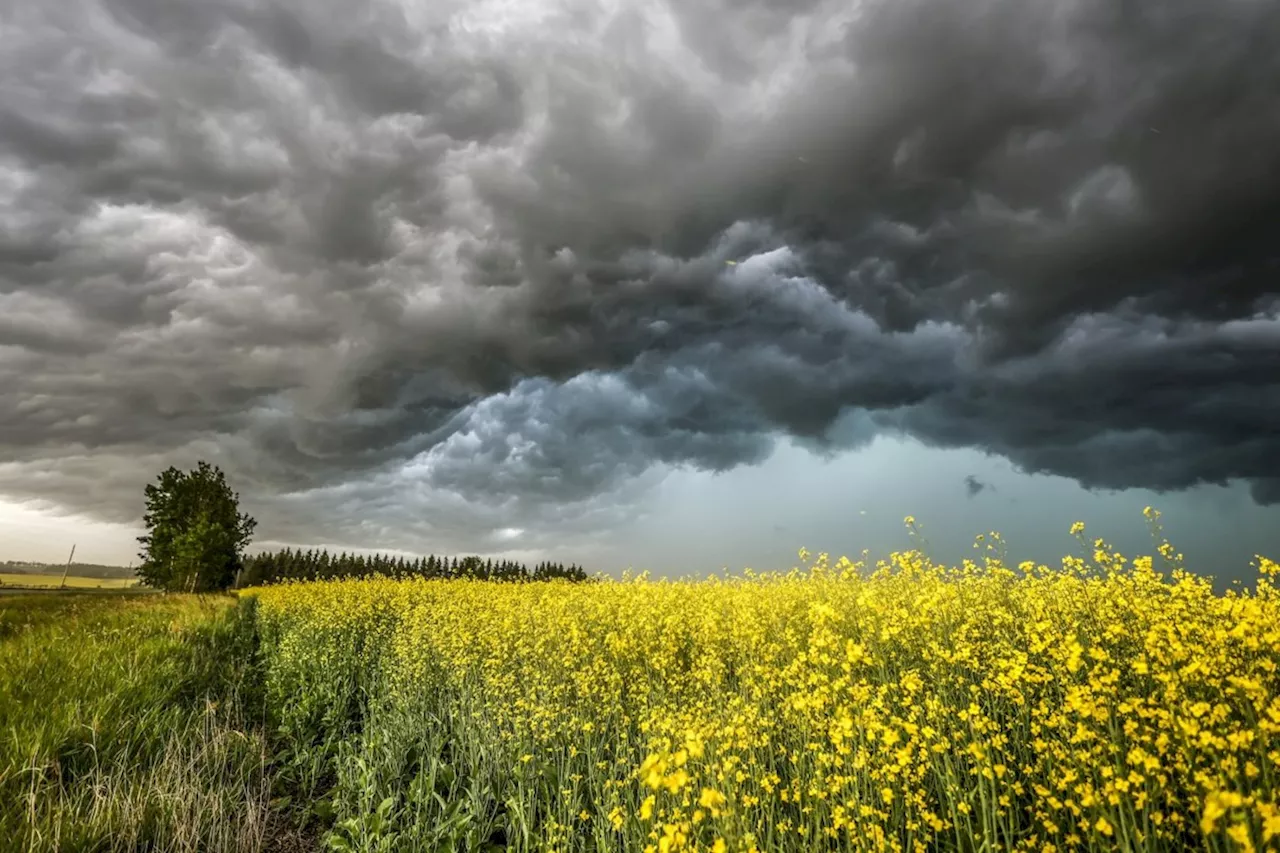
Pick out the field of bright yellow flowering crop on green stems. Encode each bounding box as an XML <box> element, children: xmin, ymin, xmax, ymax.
<box><xmin>248</xmin><ymin>514</ymin><xmax>1280</xmax><ymax>853</ymax></box>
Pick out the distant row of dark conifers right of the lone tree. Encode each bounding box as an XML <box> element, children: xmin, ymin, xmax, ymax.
<box><xmin>238</xmin><ymin>548</ymin><xmax>588</xmax><ymax>587</ymax></box>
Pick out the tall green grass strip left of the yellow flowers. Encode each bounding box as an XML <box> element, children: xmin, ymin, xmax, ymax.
<box><xmin>0</xmin><ymin>594</ymin><xmax>281</xmax><ymax>852</ymax></box>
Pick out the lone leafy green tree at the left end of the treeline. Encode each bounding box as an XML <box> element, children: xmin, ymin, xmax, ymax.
<box><xmin>138</xmin><ymin>461</ymin><xmax>257</xmax><ymax>592</ymax></box>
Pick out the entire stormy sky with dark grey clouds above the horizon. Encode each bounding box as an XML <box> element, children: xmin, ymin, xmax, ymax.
<box><xmin>0</xmin><ymin>0</ymin><xmax>1280</xmax><ymax>576</ymax></box>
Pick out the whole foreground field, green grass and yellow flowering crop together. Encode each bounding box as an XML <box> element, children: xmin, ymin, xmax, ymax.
<box><xmin>0</xmin><ymin>522</ymin><xmax>1280</xmax><ymax>853</ymax></box>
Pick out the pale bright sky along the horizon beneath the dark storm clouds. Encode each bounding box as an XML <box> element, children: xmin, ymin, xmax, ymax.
<box><xmin>0</xmin><ymin>438</ymin><xmax>1280</xmax><ymax>581</ymax></box>
